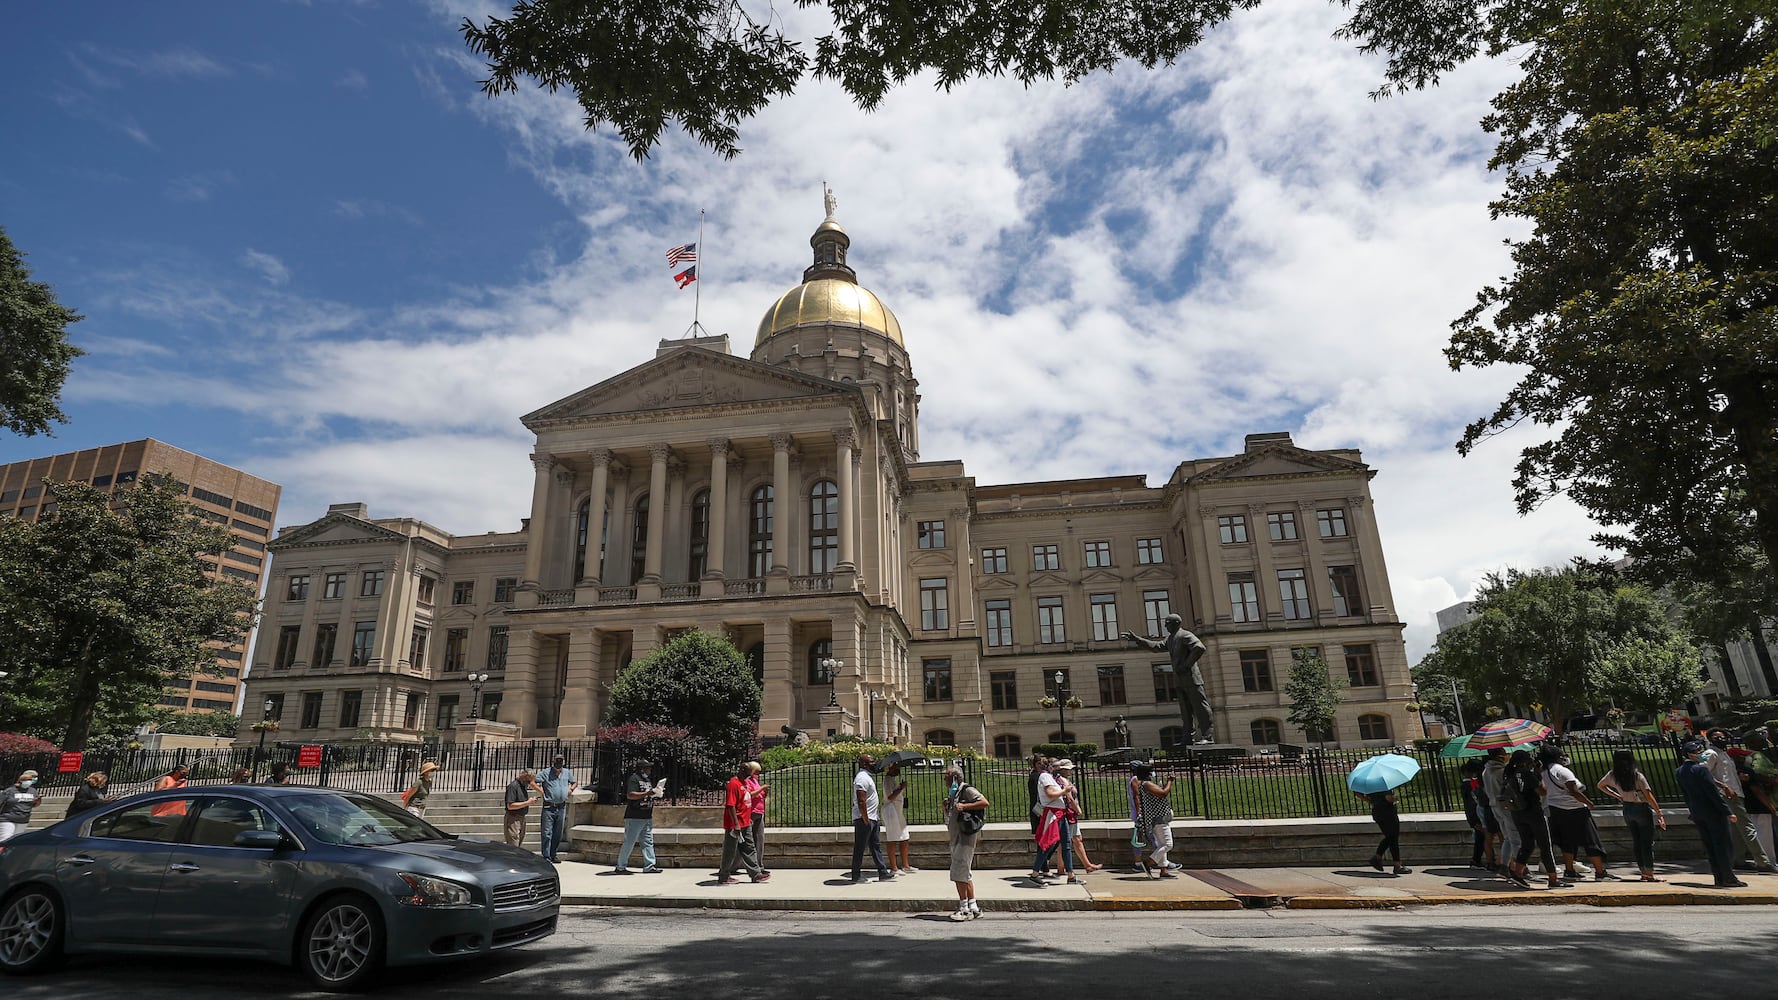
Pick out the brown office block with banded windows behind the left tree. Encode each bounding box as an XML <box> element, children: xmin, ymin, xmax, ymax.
<box><xmin>0</xmin><ymin>438</ymin><xmax>281</xmax><ymax>712</ymax></box>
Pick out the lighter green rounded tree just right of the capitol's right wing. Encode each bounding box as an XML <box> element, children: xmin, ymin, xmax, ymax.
<box><xmin>1415</xmin><ymin>562</ymin><xmax>1702</xmax><ymax>728</ymax></box>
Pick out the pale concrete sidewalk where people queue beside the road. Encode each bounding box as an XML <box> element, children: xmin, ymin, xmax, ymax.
<box><xmin>558</xmin><ymin>861</ymin><xmax>1778</xmax><ymax>913</ymax></box>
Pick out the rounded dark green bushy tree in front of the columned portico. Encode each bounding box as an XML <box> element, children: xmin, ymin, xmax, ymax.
<box><xmin>605</xmin><ymin>630</ymin><xmax>759</xmax><ymax>763</ymax></box>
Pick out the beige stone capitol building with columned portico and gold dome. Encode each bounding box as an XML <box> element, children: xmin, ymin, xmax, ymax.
<box><xmin>249</xmin><ymin>219</ymin><xmax>1419</xmax><ymax>754</ymax></box>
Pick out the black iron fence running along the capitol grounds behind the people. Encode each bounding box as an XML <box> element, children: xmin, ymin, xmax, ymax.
<box><xmin>0</xmin><ymin>740</ymin><xmax>1680</xmax><ymax>827</ymax></box>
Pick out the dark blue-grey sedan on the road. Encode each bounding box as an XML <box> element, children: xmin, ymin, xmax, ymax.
<box><xmin>0</xmin><ymin>785</ymin><xmax>560</xmax><ymax>991</ymax></box>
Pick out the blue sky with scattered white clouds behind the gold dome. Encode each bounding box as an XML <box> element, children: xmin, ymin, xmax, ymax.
<box><xmin>0</xmin><ymin>0</ymin><xmax>1614</xmax><ymax>655</ymax></box>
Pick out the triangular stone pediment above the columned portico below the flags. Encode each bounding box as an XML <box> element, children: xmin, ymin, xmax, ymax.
<box><xmin>521</xmin><ymin>347</ymin><xmax>857</xmax><ymax>423</ymax></box>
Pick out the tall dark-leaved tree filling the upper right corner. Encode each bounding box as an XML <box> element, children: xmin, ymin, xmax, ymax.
<box><xmin>1447</xmin><ymin>0</ymin><xmax>1778</xmax><ymax>597</ymax></box>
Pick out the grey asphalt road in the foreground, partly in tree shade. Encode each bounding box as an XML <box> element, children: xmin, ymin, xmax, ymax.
<box><xmin>10</xmin><ymin>906</ymin><xmax>1778</xmax><ymax>1000</ymax></box>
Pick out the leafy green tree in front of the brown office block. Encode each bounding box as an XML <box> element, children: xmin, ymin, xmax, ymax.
<box><xmin>0</xmin><ymin>480</ymin><xmax>256</xmax><ymax>749</ymax></box>
